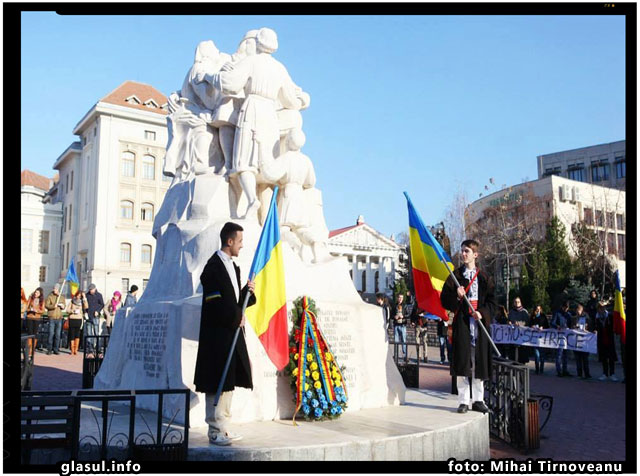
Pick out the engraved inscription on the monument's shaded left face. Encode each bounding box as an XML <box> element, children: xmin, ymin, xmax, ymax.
<box><xmin>127</xmin><ymin>312</ymin><xmax>169</xmax><ymax>378</ymax></box>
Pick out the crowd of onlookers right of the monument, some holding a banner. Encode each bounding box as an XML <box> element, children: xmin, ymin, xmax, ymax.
<box><xmin>376</xmin><ymin>282</ymin><xmax>625</xmax><ymax>383</ymax></box>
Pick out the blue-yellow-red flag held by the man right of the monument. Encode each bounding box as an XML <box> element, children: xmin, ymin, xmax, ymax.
<box><xmin>404</xmin><ymin>192</ymin><xmax>454</xmax><ymax>321</ymax></box>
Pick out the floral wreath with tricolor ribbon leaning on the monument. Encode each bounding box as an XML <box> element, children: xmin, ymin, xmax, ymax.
<box><xmin>286</xmin><ymin>296</ymin><xmax>347</xmax><ymax>425</ymax></box>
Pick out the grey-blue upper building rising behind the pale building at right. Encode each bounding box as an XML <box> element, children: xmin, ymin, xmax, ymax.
<box><xmin>538</xmin><ymin>140</ymin><xmax>627</xmax><ymax>190</ymax></box>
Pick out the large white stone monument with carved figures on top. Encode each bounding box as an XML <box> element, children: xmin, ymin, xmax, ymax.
<box><xmin>94</xmin><ymin>28</ymin><xmax>405</xmax><ymax>426</ymax></box>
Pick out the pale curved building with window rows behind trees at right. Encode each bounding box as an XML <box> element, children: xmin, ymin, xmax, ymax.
<box><xmin>465</xmin><ymin>175</ymin><xmax>627</xmax><ymax>287</ymax></box>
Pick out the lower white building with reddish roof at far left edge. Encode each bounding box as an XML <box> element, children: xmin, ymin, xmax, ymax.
<box><xmin>20</xmin><ymin>170</ymin><xmax>62</xmax><ymax>297</ymax></box>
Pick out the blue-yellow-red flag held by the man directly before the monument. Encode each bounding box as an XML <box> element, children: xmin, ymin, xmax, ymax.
<box><xmin>245</xmin><ymin>187</ymin><xmax>289</xmax><ymax>370</ymax></box>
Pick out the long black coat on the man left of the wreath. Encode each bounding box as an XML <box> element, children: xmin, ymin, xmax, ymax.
<box><xmin>194</xmin><ymin>254</ymin><xmax>256</xmax><ymax>393</ymax></box>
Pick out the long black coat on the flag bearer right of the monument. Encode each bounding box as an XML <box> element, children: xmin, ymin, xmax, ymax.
<box><xmin>440</xmin><ymin>266</ymin><xmax>498</xmax><ymax>380</ymax></box>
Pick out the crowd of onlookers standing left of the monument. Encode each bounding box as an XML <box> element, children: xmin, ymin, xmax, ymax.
<box><xmin>20</xmin><ymin>283</ymin><xmax>138</xmax><ymax>356</ymax></box>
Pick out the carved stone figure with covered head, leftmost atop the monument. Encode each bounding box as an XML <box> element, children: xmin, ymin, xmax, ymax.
<box><xmin>163</xmin><ymin>40</ymin><xmax>231</xmax><ymax>181</ymax></box>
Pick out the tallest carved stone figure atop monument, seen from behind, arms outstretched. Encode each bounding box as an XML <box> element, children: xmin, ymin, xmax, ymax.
<box><xmin>198</xmin><ymin>28</ymin><xmax>306</xmax><ymax>217</ymax></box>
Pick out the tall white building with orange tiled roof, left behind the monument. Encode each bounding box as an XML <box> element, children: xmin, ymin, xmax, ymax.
<box><xmin>51</xmin><ymin>81</ymin><xmax>171</xmax><ymax>299</ymax></box>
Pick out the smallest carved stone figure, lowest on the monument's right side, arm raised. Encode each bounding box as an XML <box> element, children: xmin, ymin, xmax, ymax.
<box><xmin>255</xmin><ymin>129</ymin><xmax>329</xmax><ymax>262</ymax></box>
